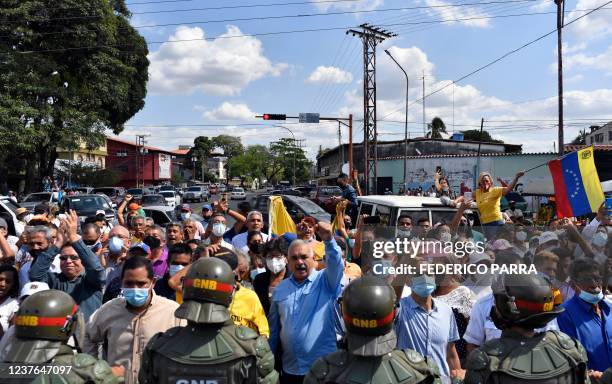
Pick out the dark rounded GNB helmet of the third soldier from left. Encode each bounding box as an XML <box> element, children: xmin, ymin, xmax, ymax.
<box><xmin>342</xmin><ymin>276</ymin><xmax>396</xmax><ymax>336</ymax></box>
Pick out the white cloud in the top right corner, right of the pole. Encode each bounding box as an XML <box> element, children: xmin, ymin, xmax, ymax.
<box><xmin>565</xmin><ymin>0</ymin><xmax>612</xmax><ymax>40</ymax></box>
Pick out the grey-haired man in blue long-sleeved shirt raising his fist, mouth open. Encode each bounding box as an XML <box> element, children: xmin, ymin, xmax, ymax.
<box><xmin>268</xmin><ymin>222</ymin><xmax>344</xmax><ymax>384</ymax></box>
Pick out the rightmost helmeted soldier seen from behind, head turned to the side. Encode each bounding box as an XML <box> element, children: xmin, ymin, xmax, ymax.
<box><xmin>464</xmin><ymin>274</ymin><xmax>590</xmax><ymax>384</ymax></box>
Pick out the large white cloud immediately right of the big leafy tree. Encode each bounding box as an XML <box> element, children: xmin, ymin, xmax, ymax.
<box><xmin>148</xmin><ymin>26</ymin><xmax>287</xmax><ymax>96</ymax></box>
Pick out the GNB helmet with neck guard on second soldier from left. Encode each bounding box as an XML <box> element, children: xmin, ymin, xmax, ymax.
<box><xmin>175</xmin><ymin>257</ymin><xmax>235</xmax><ymax>324</ymax></box>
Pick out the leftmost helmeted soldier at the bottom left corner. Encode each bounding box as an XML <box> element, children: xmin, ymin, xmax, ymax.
<box><xmin>6</xmin><ymin>289</ymin><xmax>119</xmax><ymax>384</ymax></box>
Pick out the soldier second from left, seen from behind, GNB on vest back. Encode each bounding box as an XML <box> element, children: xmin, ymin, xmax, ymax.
<box><xmin>138</xmin><ymin>257</ymin><xmax>278</xmax><ymax>384</ymax></box>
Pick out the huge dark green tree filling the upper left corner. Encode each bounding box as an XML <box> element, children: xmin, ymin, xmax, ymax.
<box><xmin>0</xmin><ymin>0</ymin><xmax>149</xmax><ymax>190</ymax></box>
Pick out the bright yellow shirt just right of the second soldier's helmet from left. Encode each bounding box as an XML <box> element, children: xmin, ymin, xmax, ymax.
<box><xmin>230</xmin><ymin>285</ymin><xmax>270</xmax><ymax>337</ymax></box>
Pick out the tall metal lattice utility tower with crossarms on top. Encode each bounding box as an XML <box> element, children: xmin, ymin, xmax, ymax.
<box><xmin>346</xmin><ymin>23</ymin><xmax>397</xmax><ymax>194</ymax></box>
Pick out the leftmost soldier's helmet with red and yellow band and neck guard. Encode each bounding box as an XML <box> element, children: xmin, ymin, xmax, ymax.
<box><xmin>7</xmin><ymin>289</ymin><xmax>78</xmax><ymax>363</ymax></box>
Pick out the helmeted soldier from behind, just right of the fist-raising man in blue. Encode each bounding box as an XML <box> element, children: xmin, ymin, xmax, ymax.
<box><xmin>304</xmin><ymin>276</ymin><xmax>440</xmax><ymax>384</ymax></box>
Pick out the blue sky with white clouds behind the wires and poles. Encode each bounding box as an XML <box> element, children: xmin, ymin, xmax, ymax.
<box><xmin>121</xmin><ymin>0</ymin><xmax>612</xmax><ymax>158</ymax></box>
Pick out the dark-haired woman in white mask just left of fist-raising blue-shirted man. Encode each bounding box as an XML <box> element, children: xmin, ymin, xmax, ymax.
<box><xmin>253</xmin><ymin>237</ymin><xmax>289</xmax><ymax>316</ymax></box>
